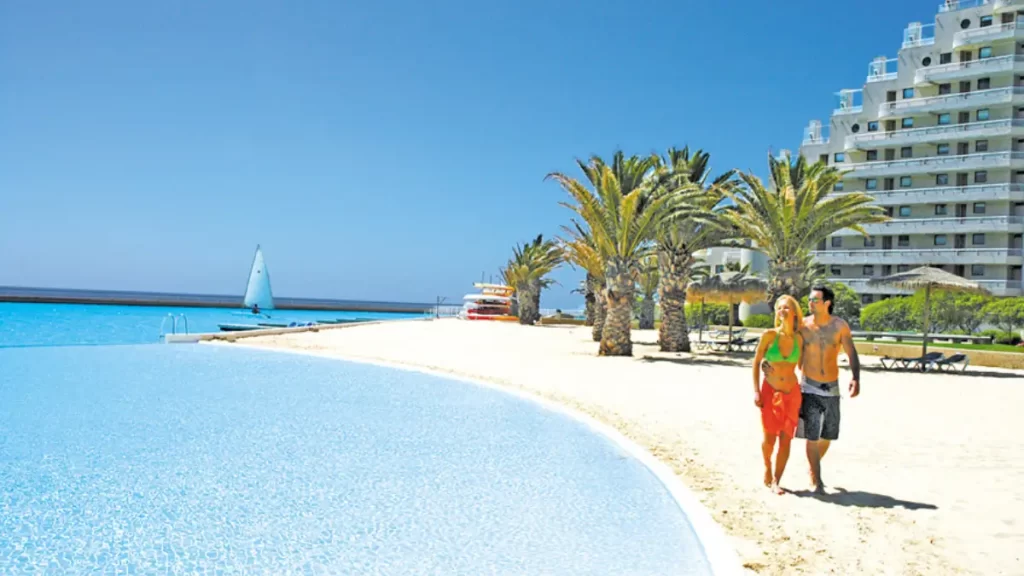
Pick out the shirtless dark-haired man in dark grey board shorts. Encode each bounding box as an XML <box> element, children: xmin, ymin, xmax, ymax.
<box><xmin>797</xmin><ymin>286</ymin><xmax>860</xmax><ymax>493</ymax></box>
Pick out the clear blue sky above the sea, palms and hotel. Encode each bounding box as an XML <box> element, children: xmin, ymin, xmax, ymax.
<box><xmin>0</xmin><ymin>0</ymin><xmax>939</xmax><ymax>307</ymax></box>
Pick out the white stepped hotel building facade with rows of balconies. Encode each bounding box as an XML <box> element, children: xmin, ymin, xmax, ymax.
<box><xmin>800</xmin><ymin>0</ymin><xmax>1024</xmax><ymax>302</ymax></box>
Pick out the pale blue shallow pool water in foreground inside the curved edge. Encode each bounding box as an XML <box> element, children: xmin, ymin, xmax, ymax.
<box><xmin>0</xmin><ymin>303</ymin><xmax>709</xmax><ymax>575</ymax></box>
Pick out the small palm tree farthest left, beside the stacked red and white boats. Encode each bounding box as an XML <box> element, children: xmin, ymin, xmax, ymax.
<box><xmin>502</xmin><ymin>234</ymin><xmax>562</xmax><ymax>324</ymax></box>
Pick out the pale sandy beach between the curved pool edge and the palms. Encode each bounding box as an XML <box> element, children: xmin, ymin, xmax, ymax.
<box><xmin>230</xmin><ymin>320</ymin><xmax>1024</xmax><ymax>575</ymax></box>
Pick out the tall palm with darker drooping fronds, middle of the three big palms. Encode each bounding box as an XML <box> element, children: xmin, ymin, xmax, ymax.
<box><xmin>653</xmin><ymin>147</ymin><xmax>735</xmax><ymax>352</ymax></box>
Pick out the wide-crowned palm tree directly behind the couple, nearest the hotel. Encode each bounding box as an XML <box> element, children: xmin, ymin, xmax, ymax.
<box><xmin>728</xmin><ymin>147</ymin><xmax>889</xmax><ymax>301</ymax></box>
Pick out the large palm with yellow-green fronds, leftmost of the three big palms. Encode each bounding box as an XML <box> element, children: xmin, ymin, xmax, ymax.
<box><xmin>547</xmin><ymin>152</ymin><xmax>669</xmax><ymax>356</ymax></box>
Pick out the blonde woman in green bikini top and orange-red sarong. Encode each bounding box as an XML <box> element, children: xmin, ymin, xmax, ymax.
<box><xmin>754</xmin><ymin>295</ymin><xmax>804</xmax><ymax>494</ymax></box>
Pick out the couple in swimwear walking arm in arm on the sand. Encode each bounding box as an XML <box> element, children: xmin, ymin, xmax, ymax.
<box><xmin>754</xmin><ymin>286</ymin><xmax>860</xmax><ymax>494</ymax></box>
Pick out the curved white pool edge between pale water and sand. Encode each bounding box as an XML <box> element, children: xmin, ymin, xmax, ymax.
<box><xmin>220</xmin><ymin>340</ymin><xmax>749</xmax><ymax>576</ymax></box>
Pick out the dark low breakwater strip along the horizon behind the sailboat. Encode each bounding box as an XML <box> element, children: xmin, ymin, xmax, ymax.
<box><xmin>0</xmin><ymin>286</ymin><xmax>434</xmax><ymax>314</ymax></box>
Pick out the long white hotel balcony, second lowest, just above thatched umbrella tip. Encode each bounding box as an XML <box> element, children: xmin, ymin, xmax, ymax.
<box><xmin>811</xmin><ymin>248</ymin><xmax>1024</xmax><ymax>265</ymax></box>
